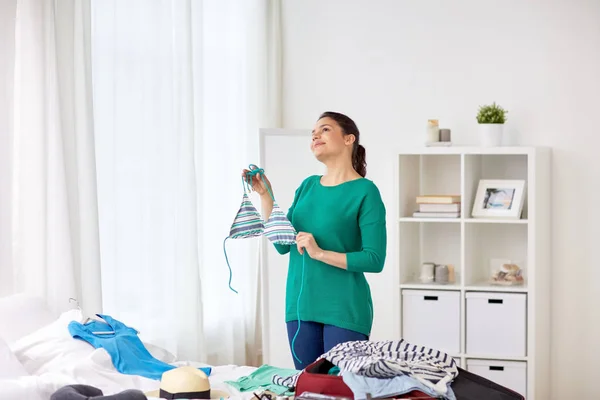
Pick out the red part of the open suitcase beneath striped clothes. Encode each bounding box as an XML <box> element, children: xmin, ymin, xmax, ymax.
<box><xmin>296</xmin><ymin>359</ymin><xmax>435</xmax><ymax>400</ymax></box>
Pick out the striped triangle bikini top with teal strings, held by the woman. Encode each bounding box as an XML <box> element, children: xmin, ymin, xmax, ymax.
<box><xmin>223</xmin><ymin>164</ymin><xmax>297</xmax><ymax>293</ymax></box>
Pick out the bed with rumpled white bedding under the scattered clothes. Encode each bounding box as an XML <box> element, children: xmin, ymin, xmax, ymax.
<box><xmin>0</xmin><ymin>295</ymin><xmax>256</xmax><ymax>400</ymax></box>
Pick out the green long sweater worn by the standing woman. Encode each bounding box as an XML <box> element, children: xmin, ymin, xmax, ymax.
<box><xmin>275</xmin><ymin>175</ymin><xmax>387</xmax><ymax>335</ymax></box>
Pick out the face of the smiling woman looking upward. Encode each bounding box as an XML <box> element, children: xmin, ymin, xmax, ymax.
<box><xmin>310</xmin><ymin>117</ymin><xmax>354</xmax><ymax>161</ymax></box>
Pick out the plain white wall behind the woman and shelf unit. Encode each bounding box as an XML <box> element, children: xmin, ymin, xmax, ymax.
<box><xmin>283</xmin><ymin>0</ymin><xmax>600</xmax><ymax>399</ymax></box>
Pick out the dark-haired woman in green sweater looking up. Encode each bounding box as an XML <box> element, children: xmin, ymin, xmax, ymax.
<box><xmin>245</xmin><ymin>112</ymin><xmax>387</xmax><ymax>370</ymax></box>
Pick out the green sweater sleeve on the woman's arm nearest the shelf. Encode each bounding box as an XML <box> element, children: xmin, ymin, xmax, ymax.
<box><xmin>346</xmin><ymin>185</ymin><xmax>387</xmax><ymax>273</ymax></box>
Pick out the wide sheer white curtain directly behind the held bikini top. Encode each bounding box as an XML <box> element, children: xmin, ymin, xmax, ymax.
<box><xmin>92</xmin><ymin>0</ymin><xmax>280</xmax><ymax>365</ymax></box>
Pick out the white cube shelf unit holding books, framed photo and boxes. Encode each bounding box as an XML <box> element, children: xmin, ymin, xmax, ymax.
<box><xmin>396</xmin><ymin>147</ymin><xmax>551</xmax><ymax>400</ymax></box>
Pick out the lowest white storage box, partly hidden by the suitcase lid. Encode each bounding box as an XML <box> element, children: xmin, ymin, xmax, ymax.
<box><xmin>467</xmin><ymin>360</ymin><xmax>527</xmax><ymax>397</ymax></box>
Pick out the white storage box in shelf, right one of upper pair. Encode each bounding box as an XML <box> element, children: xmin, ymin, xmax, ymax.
<box><xmin>466</xmin><ymin>292</ymin><xmax>527</xmax><ymax>357</ymax></box>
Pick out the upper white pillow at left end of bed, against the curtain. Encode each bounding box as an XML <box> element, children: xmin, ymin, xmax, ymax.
<box><xmin>0</xmin><ymin>293</ymin><xmax>57</xmax><ymax>345</ymax></box>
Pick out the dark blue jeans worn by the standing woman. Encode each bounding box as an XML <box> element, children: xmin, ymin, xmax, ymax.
<box><xmin>287</xmin><ymin>321</ymin><xmax>369</xmax><ymax>370</ymax></box>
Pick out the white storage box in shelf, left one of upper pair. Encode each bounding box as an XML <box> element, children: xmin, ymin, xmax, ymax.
<box><xmin>402</xmin><ymin>290</ymin><xmax>460</xmax><ymax>354</ymax></box>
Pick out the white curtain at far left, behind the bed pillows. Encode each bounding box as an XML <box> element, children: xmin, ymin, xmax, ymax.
<box><xmin>0</xmin><ymin>0</ymin><xmax>102</xmax><ymax>312</ymax></box>
